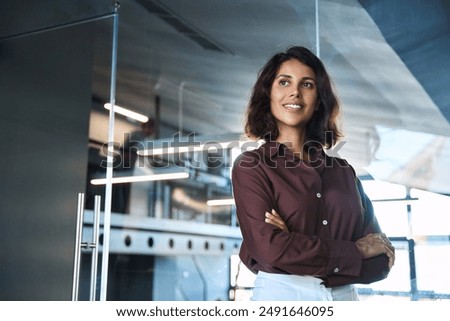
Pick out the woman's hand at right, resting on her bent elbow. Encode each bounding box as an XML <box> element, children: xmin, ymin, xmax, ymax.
<box><xmin>356</xmin><ymin>233</ymin><xmax>395</xmax><ymax>270</ymax></box>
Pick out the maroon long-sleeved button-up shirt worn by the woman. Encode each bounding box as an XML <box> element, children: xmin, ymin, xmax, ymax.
<box><xmin>232</xmin><ymin>142</ymin><xmax>388</xmax><ymax>287</ymax></box>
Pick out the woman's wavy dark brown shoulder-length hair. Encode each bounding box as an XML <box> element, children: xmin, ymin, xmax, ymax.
<box><xmin>244</xmin><ymin>46</ymin><xmax>342</xmax><ymax>148</ymax></box>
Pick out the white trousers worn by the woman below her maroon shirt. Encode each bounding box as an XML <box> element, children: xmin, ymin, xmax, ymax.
<box><xmin>251</xmin><ymin>272</ymin><xmax>359</xmax><ymax>301</ymax></box>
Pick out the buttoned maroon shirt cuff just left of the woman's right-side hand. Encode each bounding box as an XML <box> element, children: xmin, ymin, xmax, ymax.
<box><xmin>326</xmin><ymin>240</ymin><xmax>363</xmax><ymax>277</ymax></box>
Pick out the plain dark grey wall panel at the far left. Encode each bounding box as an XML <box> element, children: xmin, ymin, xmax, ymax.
<box><xmin>0</xmin><ymin>18</ymin><xmax>94</xmax><ymax>300</ymax></box>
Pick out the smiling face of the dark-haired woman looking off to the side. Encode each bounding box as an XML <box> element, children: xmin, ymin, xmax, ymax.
<box><xmin>270</xmin><ymin>59</ymin><xmax>317</xmax><ymax>135</ymax></box>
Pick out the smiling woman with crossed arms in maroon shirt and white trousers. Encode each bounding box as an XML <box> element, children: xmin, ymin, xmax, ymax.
<box><xmin>232</xmin><ymin>47</ymin><xmax>395</xmax><ymax>301</ymax></box>
